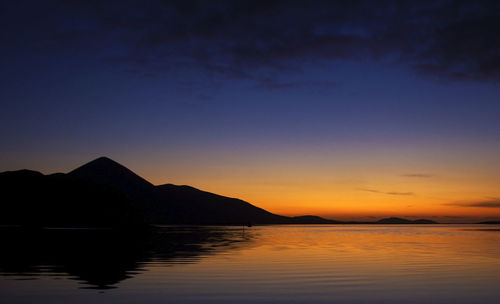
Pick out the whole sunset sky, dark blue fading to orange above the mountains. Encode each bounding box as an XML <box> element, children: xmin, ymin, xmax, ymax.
<box><xmin>0</xmin><ymin>0</ymin><xmax>500</xmax><ymax>222</ymax></box>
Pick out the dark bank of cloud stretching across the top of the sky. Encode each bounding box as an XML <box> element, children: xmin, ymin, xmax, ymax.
<box><xmin>0</xmin><ymin>0</ymin><xmax>500</xmax><ymax>82</ymax></box>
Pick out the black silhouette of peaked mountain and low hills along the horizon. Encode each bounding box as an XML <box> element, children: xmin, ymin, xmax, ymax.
<box><xmin>0</xmin><ymin>157</ymin><xmax>436</xmax><ymax>228</ymax></box>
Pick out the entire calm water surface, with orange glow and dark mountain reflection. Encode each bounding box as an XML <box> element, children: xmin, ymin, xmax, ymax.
<box><xmin>0</xmin><ymin>225</ymin><xmax>500</xmax><ymax>304</ymax></box>
